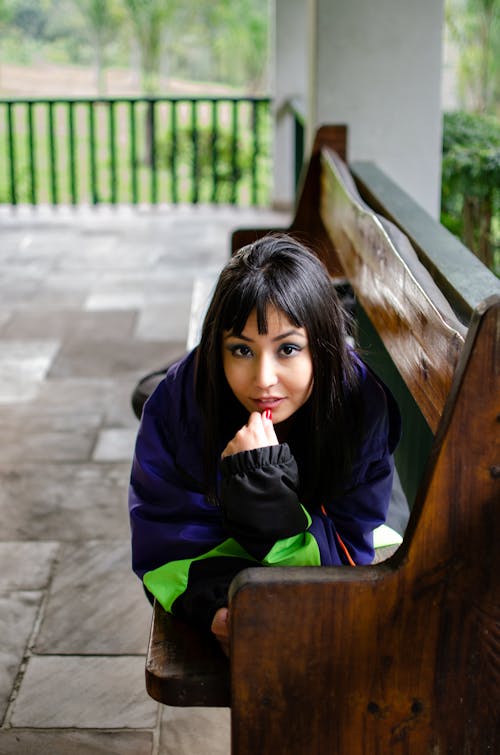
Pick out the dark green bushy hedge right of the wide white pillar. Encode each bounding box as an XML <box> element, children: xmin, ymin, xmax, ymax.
<box><xmin>441</xmin><ymin>112</ymin><xmax>500</xmax><ymax>273</ymax></box>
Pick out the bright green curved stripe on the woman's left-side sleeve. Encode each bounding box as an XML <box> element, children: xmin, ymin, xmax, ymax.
<box><xmin>143</xmin><ymin>538</ymin><xmax>258</xmax><ymax>611</ymax></box>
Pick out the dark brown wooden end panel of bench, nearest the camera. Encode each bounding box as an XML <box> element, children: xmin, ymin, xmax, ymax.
<box><xmin>232</xmin><ymin>299</ymin><xmax>500</xmax><ymax>755</ymax></box>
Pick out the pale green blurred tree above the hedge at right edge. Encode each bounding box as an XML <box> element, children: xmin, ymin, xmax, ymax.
<box><xmin>446</xmin><ymin>0</ymin><xmax>500</xmax><ymax>114</ymax></box>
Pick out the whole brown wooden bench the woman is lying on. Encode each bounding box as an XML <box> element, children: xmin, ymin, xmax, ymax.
<box><xmin>146</xmin><ymin>126</ymin><xmax>500</xmax><ymax>755</ymax></box>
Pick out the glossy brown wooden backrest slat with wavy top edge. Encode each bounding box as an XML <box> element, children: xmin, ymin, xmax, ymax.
<box><xmin>321</xmin><ymin>149</ymin><xmax>466</xmax><ymax>432</ymax></box>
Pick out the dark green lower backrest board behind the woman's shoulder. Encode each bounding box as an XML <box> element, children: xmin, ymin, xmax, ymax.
<box><xmin>356</xmin><ymin>303</ymin><xmax>434</xmax><ymax>508</ymax></box>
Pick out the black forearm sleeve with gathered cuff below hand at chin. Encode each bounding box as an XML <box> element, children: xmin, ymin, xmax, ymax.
<box><xmin>221</xmin><ymin>443</ymin><xmax>307</xmax><ymax>559</ymax></box>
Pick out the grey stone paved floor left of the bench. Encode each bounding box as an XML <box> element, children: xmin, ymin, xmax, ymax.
<box><xmin>0</xmin><ymin>202</ymin><xmax>287</xmax><ymax>755</ymax></box>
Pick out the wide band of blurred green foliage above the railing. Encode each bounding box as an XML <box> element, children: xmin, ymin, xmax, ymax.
<box><xmin>0</xmin><ymin>0</ymin><xmax>271</xmax><ymax>94</ymax></box>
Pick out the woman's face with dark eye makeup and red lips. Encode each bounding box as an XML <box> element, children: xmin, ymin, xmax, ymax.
<box><xmin>222</xmin><ymin>307</ymin><xmax>313</xmax><ymax>424</ymax></box>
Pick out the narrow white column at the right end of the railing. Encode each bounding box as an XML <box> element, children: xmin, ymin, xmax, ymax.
<box><xmin>272</xmin><ymin>0</ymin><xmax>308</xmax><ymax>209</ymax></box>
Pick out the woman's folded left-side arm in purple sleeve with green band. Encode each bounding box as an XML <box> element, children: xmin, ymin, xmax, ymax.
<box><xmin>129</xmin><ymin>372</ymin><xmax>255</xmax><ymax>628</ymax></box>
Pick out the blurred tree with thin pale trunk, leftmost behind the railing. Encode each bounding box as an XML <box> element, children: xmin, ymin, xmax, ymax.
<box><xmin>73</xmin><ymin>0</ymin><xmax>123</xmax><ymax>95</ymax></box>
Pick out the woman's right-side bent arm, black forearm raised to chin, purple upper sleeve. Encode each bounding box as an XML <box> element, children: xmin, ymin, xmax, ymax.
<box><xmin>221</xmin><ymin>371</ymin><xmax>400</xmax><ymax>565</ymax></box>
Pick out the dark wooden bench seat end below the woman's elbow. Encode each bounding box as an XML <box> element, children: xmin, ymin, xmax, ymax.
<box><xmin>146</xmin><ymin>601</ymin><xmax>230</xmax><ymax>707</ymax></box>
